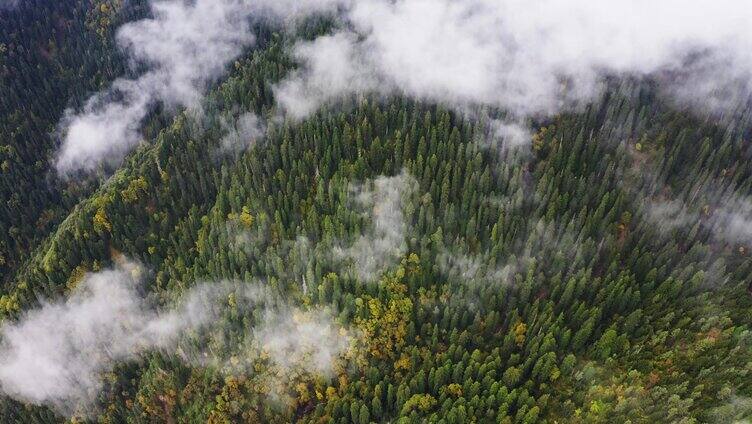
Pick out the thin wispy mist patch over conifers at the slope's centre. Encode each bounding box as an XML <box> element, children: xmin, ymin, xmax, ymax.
<box><xmin>225</xmin><ymin>171</ymin><xmax>418</xmax><ymax>284</ymax></box>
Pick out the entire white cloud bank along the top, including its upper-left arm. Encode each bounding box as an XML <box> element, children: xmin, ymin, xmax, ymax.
<box><xmin>55</xmin><ymin>0</ymin><xmax>752</xmax><ymax>169</ymax></box>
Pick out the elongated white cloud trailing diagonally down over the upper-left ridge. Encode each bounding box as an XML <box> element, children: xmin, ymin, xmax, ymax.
<box><xmin>55</xmin><ymin>0</ymin><xmax>344</xmax><ymax>175</ymax></box>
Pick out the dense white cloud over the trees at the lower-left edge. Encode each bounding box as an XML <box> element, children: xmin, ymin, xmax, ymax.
<box><xmin>0</xmin><ymin>265</ymin><xmax>189</xmax><ymax>413</ymax></box>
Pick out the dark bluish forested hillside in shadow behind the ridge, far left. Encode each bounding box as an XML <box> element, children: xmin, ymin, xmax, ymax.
<box><xmin>0</xmin><ymin>1</ymin><xmax>150</xmax><ymax>284</ymax></box>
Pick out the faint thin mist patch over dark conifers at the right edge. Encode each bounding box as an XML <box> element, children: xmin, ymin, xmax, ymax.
<box><xmin>616</xmin><ymin>147</ymin><xmax>752</xmax><ymax>289</ymax></box>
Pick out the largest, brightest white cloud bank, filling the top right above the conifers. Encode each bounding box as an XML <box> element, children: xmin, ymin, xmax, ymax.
<box><xmin>277</xmin><ymin>0</ymin><xmax>752</xmax><ymax>124</ymax></box>
